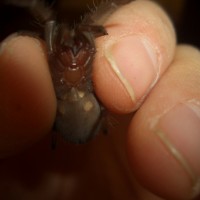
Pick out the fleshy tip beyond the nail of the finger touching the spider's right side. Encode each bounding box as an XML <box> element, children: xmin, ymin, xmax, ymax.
<box><xmin>93</xmin><ymin>50</ymin><xmax>133</xmax><ymax>113</ymax></box>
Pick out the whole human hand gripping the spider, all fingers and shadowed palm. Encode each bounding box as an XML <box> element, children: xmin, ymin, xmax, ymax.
<box><xmin>0</xmin><ymin>0</ymin><xmax>200</xmax><ymax>200</ymax></box>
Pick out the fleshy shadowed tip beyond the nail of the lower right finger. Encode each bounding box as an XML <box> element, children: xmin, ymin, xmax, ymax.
<box><xmin>127</xmin><ymin>115</ymin><xmax>194</xmax><ymax>200</ymax></box>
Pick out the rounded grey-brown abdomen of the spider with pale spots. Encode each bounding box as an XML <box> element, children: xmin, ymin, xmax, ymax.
<box><xmin>55</xmin><ymin>88</ymin><xmax>101</xmax><ymax>143</ymax></box>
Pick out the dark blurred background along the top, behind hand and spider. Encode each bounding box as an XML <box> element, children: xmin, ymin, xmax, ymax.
<box><xmin>0</xmin><ymin>0</ymin><xmax>200</xmax><ymax>47</ymax></box>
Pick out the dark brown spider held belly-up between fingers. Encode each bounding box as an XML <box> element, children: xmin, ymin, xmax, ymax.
<box><xmin>3</xmin><ymin>0</ymin><xmax>107</xmax><ymax>145</ymax></box>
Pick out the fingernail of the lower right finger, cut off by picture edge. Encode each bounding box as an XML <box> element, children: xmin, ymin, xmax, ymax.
<box><xmin>156</xmin><ymin>101</ymin><xmax>200</xmax><ymax>199</ymax></box>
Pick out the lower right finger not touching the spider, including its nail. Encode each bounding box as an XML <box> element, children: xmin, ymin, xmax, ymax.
<box><xmin>127</xmin><ymin>46</ymin><xmax>200</xmax><ymax>200</ymax></box>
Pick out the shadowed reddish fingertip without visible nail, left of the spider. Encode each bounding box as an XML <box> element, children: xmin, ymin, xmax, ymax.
<box><xmin>0</xmin><ymin>34</ymin><xmax>56</xmax><ymax>157</ymax></box>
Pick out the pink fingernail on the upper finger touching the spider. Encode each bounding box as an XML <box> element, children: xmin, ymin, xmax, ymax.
<box><xmin>105</xmin><ymin>36</ymin><xmax>159</xmax><ymax>102</ymax></box>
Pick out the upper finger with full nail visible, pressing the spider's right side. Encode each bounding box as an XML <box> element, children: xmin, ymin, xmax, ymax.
<box><xmin>94</xmin><ymin>1</ymin><xmax>176</xmax><ymax>114</ymax></box>
